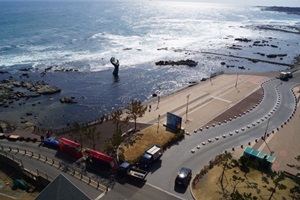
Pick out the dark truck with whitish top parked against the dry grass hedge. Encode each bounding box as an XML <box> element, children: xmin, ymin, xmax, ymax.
<box><xmin>139</xmin><ymin>144</ymin><xmax>163</xmax><ymax>168</ymax></box>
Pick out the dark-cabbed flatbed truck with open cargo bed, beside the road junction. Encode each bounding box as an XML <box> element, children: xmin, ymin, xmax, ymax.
<box><xmin>117</xmin><ymin>162</ymin><xmax>148</xmax><ymax>180</ymax></box>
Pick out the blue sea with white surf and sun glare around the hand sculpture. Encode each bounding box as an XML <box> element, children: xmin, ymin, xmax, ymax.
<box><xmin>0</xmin><ymin>0</ymin><xmax>300</xmax><ymax>128</ymax></box>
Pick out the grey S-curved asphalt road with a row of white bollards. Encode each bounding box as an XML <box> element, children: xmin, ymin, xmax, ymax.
<box><xmin>147</xmin><ymin>78</ymin><xmax>299</xmax><ymax>199</ymax></box>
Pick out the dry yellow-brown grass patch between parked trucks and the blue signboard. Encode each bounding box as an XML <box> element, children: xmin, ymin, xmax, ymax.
<box><xmin>120</xmin><ymin>125</ymin><xmax>176</xmax><ymax>163</ymax></box>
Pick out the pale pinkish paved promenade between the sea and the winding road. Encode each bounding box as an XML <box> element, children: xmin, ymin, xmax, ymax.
<box><xmin>138</xmin><ymin>74</ymin><xmax>268</xmax><ymax>132</ymax></box>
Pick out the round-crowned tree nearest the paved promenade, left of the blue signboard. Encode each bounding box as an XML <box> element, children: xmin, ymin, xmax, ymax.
<box><xmin>126</xmin><ymin>100</ymin><xmax>147</xmax><ymax>131</ymax></box>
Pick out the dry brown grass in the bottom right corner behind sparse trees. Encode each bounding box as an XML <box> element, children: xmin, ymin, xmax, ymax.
<box><xmin>192</xmin><ymin>161</ymin><xmax>296</xmax><ymax>200</ymax></box>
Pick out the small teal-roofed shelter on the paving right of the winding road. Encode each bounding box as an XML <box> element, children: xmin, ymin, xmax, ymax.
<box><xmin>244</xmin><ymin>147</ymin><xmax>276</xmax><ymax>170</ymax></box>
